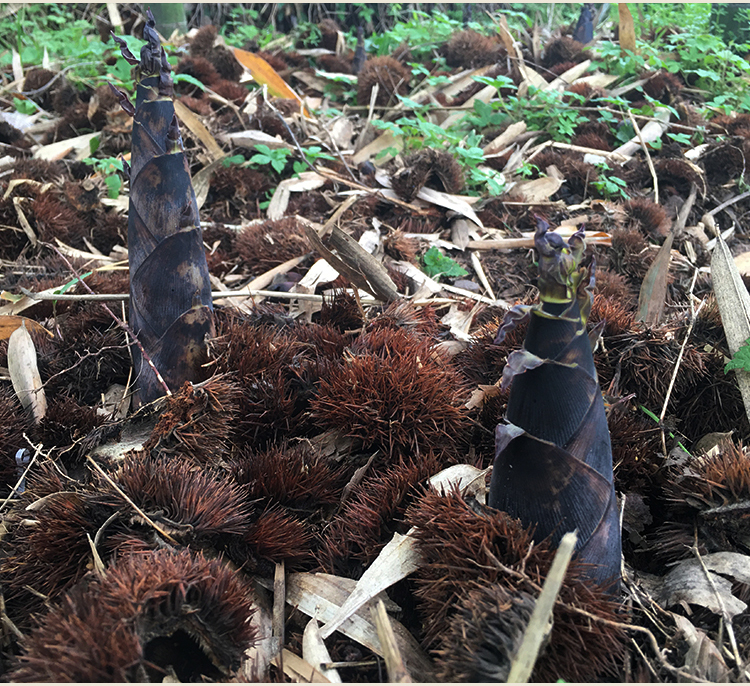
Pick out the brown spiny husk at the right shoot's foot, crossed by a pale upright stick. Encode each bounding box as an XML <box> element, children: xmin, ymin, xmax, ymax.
<box><xmin>406</xmin><ymin>492</ymin><xmax>627</xmax><ymax>681</ymax></box>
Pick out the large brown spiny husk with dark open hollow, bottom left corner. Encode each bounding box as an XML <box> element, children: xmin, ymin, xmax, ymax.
<box><xmin>14</xmin><ymin>549</ymin><xmax>255</xmax><ymax>681</ymax></box>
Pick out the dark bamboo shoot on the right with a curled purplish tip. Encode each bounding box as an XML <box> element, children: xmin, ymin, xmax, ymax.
<box><xmin>488</xmin><ymin>221</ymin><xmax>621</xmax><ymax>591</ymax></box>
